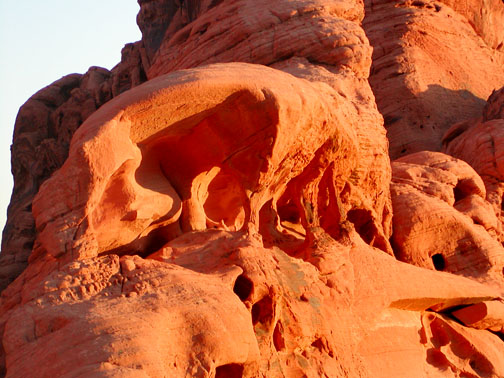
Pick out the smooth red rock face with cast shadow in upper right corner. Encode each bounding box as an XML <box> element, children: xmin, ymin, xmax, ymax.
<box><xmin>363</xmin><ymin>0</ymin><xmax>504</xmax><ymax>159</ymax></box>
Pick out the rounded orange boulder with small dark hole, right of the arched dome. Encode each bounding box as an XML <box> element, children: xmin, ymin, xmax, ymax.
<box><xmin>391</xmin><ymin>151</ymin><xmax>504</xmax><ymax>286</ymax></box>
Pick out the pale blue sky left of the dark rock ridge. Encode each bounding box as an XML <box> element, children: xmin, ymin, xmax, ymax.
<box><xmin>0</xmin><ymin>0</ymin><xmax>141</xmax><ymax>239</ymax></box>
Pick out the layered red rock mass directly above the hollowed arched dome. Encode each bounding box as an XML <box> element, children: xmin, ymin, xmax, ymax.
<box><xmin>147</xmin><ymin>0</ymin><xmax>370</xmax><ymax>78</ymax></box>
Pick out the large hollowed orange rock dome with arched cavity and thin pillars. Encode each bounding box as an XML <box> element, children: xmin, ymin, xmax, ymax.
<box><xmin>32</xmin><ymin>64</ymin><xmax>390</xmax><ymax>259</ymax></box>
